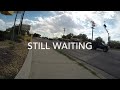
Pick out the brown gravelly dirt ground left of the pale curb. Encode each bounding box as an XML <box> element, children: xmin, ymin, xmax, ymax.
<box><xmin>0</xmin><ymin>40</ymin><xmax>28</xmax><ymax>79</ymax></box>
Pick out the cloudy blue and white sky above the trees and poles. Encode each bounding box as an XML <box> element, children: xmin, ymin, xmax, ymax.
<box><xmin>0</xmin><ymin>11</ymin><xmax>120</xmax><ymax>42</ymax></box>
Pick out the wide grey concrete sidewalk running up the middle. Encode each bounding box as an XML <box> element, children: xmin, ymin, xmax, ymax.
<box><xmin>28</xmin><ymin>44</ymin><xmax>99</xmax><ymax>79</ymax></box>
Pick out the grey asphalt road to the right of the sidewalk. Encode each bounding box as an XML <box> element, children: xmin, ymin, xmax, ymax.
<box><xmin>38</xmin><ymin>39</ymin><xmax>120</xmax><ymax>78</ymax></box>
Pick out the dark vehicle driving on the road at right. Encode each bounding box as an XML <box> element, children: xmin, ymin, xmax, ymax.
<box><xmin>92</xmin><ymin>41</ymin><xmax>109</xmax><ymax>52</ymax></box>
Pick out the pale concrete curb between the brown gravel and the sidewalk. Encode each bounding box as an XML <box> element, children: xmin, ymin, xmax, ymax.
<box><xmin>15</xmin><ymin>50</ymin><xmax>32</xmax><ymax>79</ymax></box>
